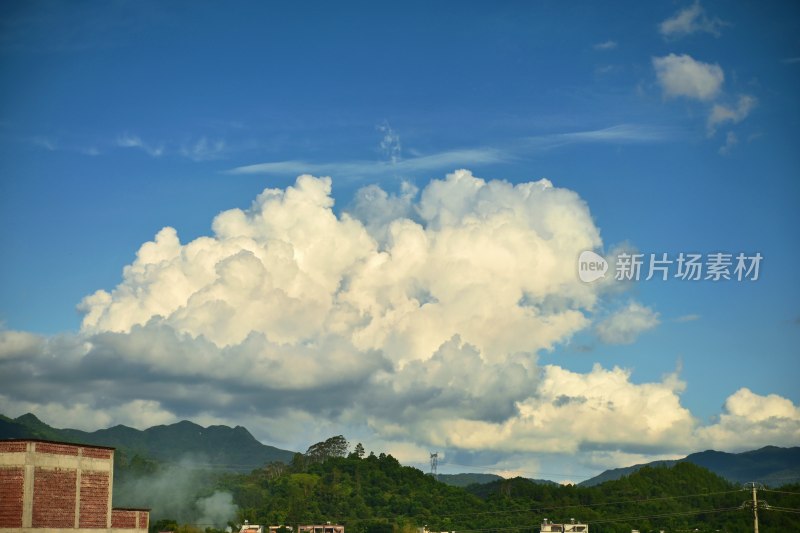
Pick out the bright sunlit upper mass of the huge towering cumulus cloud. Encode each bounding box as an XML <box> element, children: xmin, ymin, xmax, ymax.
<box><xmin>81</xmin><ymin>171</ymin><xmax>600</xmax><ymax>360</ymax></box>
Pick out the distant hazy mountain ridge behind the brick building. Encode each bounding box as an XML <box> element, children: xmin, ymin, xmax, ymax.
<box><xmin>0</xmin><ymin>413</ymin><xmax>295</xmax><ymax>472</ymax></box>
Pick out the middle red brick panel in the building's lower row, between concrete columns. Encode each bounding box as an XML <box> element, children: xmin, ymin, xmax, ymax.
<box><xmin>31</xmin><ymin>468</ymin><xmax>78</xmax><ymax>528</ymax></box>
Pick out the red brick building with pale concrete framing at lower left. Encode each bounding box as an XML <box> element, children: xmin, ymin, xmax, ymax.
<box><xmin>0</xmin><ymin>439</ymin><xmax>150</xmax><ymax>533</ymax></box>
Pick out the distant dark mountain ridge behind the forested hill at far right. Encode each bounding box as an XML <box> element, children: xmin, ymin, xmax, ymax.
<box><xmin>579</xmin><ymin>446</ymin><xmax>800</xmax><ymax>487</ymax></box>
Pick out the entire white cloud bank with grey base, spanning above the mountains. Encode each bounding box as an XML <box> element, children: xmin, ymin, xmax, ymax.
<box><xmin>0</xmin><ymin>170</ymin><xmax>798</xmax><ymax>465</ymax></box>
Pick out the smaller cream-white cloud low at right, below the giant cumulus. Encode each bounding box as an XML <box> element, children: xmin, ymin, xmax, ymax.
<box><xmin>422</xmin><ymin>365</ymin><xmax>696</xmax><ymax>453</ymax></box>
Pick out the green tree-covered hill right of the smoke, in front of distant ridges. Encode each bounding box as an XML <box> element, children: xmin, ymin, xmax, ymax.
<box><xmin>152</xmin><ymin>437</ymin><xmax>800</xmax><ymax>533</ymax></box>
